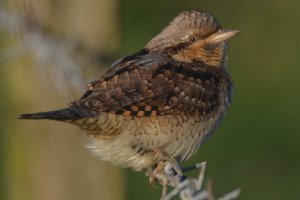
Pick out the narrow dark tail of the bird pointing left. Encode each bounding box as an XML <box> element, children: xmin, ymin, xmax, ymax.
<box><xmin>18</xmin><ymin>107</ymin><xmax>97</xmax><ymax>121</ymax></box>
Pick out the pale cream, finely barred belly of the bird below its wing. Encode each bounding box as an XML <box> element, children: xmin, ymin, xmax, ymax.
<box><xmin>88</xmin><ymin>114</ymin><xmax>217</xmax><ymax>170</ymax></box>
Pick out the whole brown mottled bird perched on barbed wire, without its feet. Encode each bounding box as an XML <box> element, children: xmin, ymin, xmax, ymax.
<box><xmin>20</xmin><ymin>11</ymin><xmax>238</xmax><ymax>170</ymax></box>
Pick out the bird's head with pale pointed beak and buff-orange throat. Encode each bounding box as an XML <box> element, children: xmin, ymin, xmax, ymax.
<box><xmin>146</xmin><ymin>11</ymin><xmax>239</xmax><ymax>67</ymax></box>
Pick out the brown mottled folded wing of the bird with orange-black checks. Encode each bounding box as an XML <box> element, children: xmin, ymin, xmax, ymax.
<box><xmin>71</xmin><ymin>52</ymin><xmax>227</xmax><ymax>116</ymax></box>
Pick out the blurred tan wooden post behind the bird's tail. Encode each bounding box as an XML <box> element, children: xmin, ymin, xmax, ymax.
<box><xmin>6</xmin><ymin>0</ymin><xmax>125</xmax><ymax>200</ymax></box>
